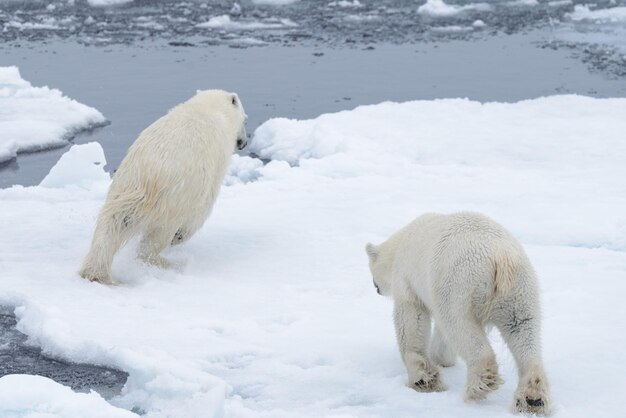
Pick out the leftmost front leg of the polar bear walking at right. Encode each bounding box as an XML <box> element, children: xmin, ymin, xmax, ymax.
<box><xmin>393</xmin><ymin>300</ymin><xmax>445</xmax><ymax>392</ymax></box>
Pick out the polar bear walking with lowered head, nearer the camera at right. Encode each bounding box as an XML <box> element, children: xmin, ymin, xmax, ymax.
<box><xmin>366</xmin><ymin>212</ymin><xmax>550</xmax><ymax>414</ymax></box>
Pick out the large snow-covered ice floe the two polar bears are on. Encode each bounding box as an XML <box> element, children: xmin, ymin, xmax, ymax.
<box><xmin>0</xmin><ymin>96</ymin><xmax>626</xmax><ymax>418</ymax></box>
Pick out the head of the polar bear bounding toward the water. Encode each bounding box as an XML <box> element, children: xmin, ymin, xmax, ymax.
<box><xmin>189</xmin><ymin>90</ymin><xmax>248</xmax><ymax>150</ymax></box>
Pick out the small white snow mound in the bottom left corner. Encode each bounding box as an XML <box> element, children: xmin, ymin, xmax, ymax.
<box><xmin>0</xmin><ymin>375</ymin><xmax>138</xmax><ymax>418</ymax></box>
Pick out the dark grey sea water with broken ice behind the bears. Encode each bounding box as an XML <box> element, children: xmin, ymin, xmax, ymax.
<box><xmin>0</xmin><ymin>0</ymin><xmax>626</xmax><ymax>187</ymax></box>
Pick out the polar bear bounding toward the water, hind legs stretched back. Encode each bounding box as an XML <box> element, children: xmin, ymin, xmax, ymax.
<box><xmin>79</xmin><ymin>90</ymin><xmax>247</xmax><ymax>283</ymax></box>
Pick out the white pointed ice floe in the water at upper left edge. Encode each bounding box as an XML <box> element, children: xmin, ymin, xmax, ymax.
<box><xmin>0</xmin><ymin>67</ymin><xmax>106</xmax><ymax>163</ymax></box>
